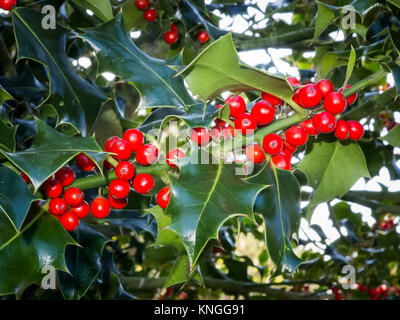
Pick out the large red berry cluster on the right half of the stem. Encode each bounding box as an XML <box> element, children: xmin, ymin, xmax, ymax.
<box><xmin>191</xmin><ymin>78</ymin><xmax>364</xmax><ymax>170</ymax></box>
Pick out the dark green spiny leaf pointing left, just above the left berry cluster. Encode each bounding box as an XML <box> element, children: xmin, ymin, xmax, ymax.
<box><xmin>0</xmin><ymin>118</ymin><xmax>107</xmax><ymax>191</ymax></box>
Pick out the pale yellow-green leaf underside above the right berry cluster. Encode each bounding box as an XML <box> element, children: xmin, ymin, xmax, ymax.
<box><xmin>179</xmin><ymin>34</ymin><xmax>293</xmax><ymax>103</ymax></box>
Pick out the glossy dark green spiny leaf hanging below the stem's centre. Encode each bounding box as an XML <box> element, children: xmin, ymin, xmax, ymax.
<box><xmin>166</xmin><ymin>151</ymin><xmax>265</xmax><ymax>266</ymax></box>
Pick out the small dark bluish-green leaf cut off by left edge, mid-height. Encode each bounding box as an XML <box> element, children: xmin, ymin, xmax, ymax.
<box><xmin>0</xmin><ymin>167</ymin><xmax>34</xmax><ymax>232</ymax></box>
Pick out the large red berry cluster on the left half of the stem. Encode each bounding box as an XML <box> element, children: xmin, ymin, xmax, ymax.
<box><xmin>21</xmin><ymin>129</ymin><xmax>186</xmax><ymax>231</ymax></box>
